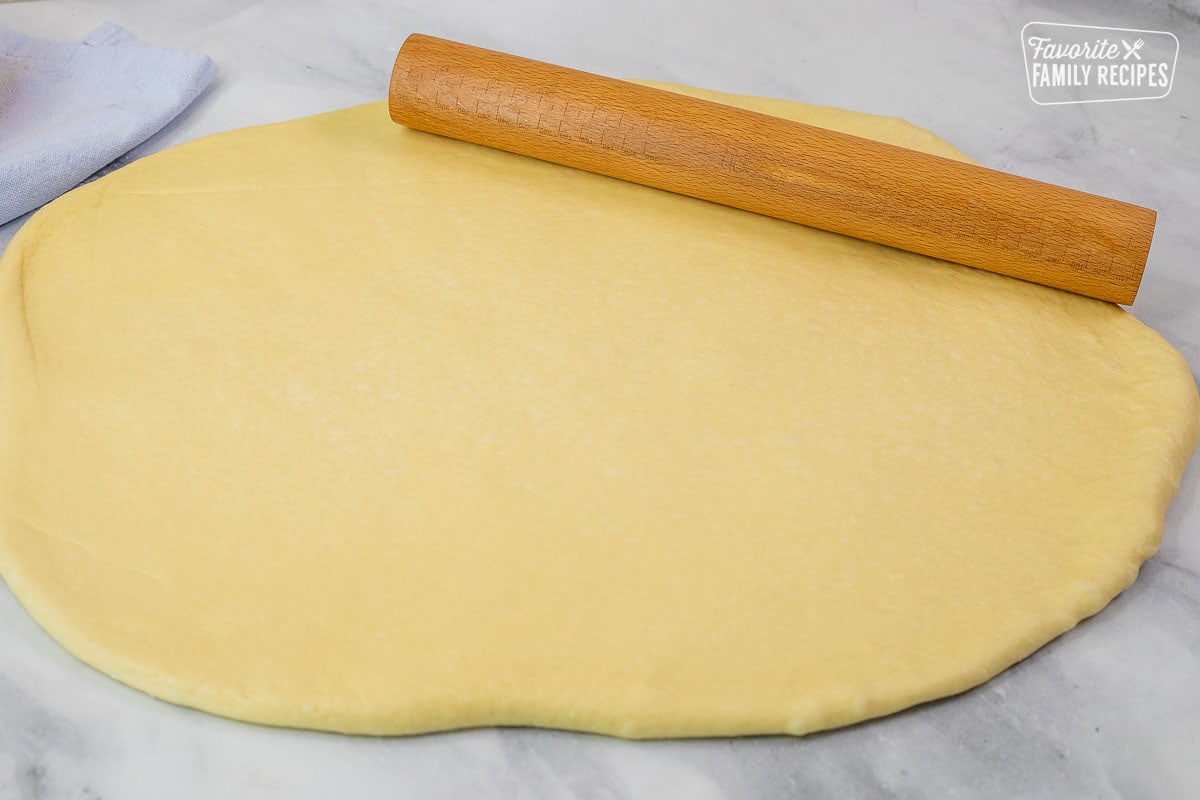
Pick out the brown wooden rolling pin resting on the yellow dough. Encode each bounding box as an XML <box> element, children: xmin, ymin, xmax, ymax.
<box><xmin>388</xmin><ymin>34</ymin><xmax>1156</xmax><ymax>305</ymax></box>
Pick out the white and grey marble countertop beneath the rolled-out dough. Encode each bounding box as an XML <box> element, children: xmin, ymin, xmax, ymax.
<box><xmin>0</xmin><ymin>0</ymin><xmax>1200</xmax><ymax>800</ymax></box>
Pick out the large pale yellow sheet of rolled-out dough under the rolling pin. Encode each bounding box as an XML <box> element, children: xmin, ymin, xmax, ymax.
<box><xmin>0</xmin><ymin>87</ymin><xmax>1200</xmax><ymax>736</ymax></box>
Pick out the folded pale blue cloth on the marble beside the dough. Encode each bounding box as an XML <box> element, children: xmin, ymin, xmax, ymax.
<box><xmin>0</xmin><ymin>23</ymin><xmax>217</xmax><ymax>224</ymax></box>
